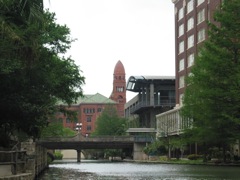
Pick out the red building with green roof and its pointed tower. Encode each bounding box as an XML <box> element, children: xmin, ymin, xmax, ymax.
<box><xmin>56</xmin><ymin>60</ymin><xmax>126</xmax><ymax>136</ymax></box>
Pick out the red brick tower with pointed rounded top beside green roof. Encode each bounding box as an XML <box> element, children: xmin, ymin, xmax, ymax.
<box><xmin>110</xmin><ymin>60</ymin><xmax>126</xmax><ymax>117</ymax></box>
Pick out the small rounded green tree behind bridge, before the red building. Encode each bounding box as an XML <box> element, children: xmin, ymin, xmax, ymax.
<box><xmin>92</xmin><ymin>105</ymin><xmax>127</xmax><ymax>136</ymax></box>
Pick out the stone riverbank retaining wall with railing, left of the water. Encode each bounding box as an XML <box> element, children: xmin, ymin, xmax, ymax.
<box><xmin>0</xmin><ymin>141</ymin><xmax>48</xmax><ymax>180</ymax></box>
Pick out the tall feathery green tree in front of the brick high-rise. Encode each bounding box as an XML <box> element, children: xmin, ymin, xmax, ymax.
<box><xmin>182</xmin><ymin>0</ymin><xmax>240</xmax><ymax>160</ymax></box>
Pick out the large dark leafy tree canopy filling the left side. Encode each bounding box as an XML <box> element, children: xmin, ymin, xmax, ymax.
<box><xmin>0</xmin><ymin>0</ymin><xmax>85</xmax><ymax>146</ymax></box>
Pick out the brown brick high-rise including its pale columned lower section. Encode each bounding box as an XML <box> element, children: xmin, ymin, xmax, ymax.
<box><xmin>156</xmin><ymin>0</ymin><xmax>223</xmax><ymax>142</ymax></box>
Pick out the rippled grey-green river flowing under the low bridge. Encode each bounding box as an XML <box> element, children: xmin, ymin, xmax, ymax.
<box><xmin>37</xmin><ymin>160</ymin><xmax>240</xmax><ymax>180</ymax></box>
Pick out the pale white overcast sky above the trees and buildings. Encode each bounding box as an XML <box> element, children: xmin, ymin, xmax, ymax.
<box><xmin>44</xmin><ymin>0</ymin><xmax>175</xmax><ymax>101</ymax></box>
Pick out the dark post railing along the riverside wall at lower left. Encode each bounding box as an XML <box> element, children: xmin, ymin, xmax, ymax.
<box><xmin>0</xmin><ymin>151</ymin><xmax>26</xmax><ymax>175</ymax></box>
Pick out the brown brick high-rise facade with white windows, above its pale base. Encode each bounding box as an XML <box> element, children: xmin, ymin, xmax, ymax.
<box><xmin>172</xmin><ymin>0</ymin><xmax>222</xmax><ymax>106</ymax></box>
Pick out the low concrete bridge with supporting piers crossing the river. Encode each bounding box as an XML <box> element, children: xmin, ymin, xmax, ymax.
<box><xmin>36</xmin><ymin>134</ymin><xmax>150</xmax><ymax>162</ymax></box>
